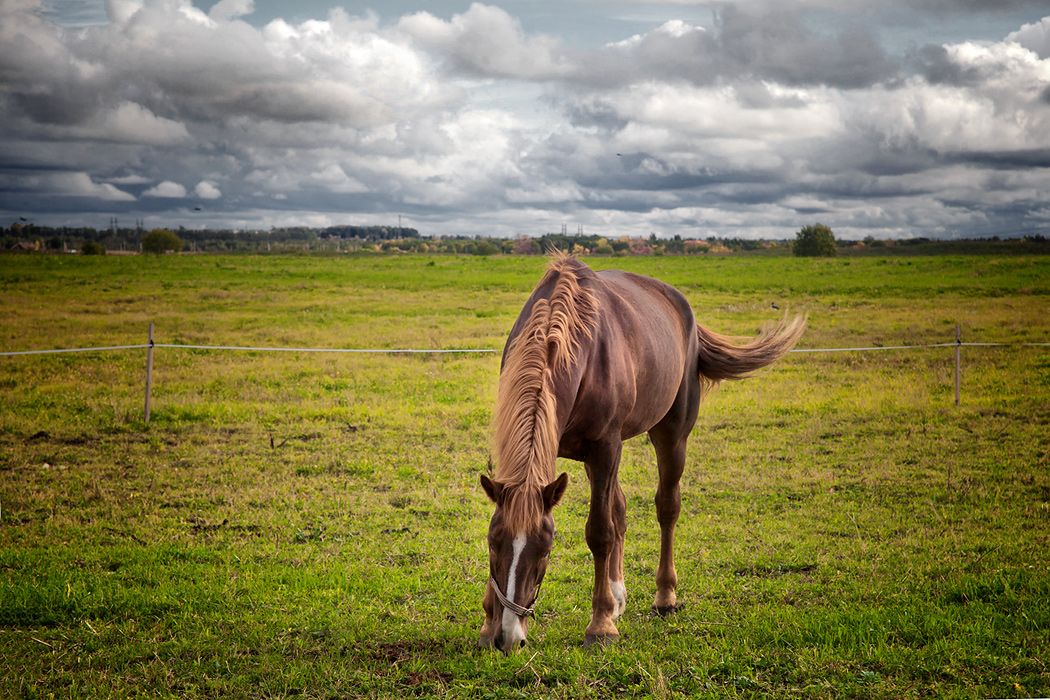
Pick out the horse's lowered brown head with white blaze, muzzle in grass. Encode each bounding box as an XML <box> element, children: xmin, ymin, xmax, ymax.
<box><xmin>481</xmin><ymin>473</ymin><xmax>569</xmax><ymax>652</ymax></box>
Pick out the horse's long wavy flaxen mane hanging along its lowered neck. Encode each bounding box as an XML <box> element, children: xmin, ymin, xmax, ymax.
<box><xmin>492</xmin><ymin>251</ymin><xmax>599</xmax><ymax>532</ymax></box>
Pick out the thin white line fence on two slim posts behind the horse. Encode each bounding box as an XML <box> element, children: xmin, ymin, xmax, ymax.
<box><xmin>0</xmin><ymin>323</ymin><xmax>1050</xmax><ymax>423</ymax></box>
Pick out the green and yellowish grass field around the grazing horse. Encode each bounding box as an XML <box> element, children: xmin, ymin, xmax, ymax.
<box><xmin>0</xmin><ymin>256</ymin><xmax>1050</xmax><ymax>698</ymax></box>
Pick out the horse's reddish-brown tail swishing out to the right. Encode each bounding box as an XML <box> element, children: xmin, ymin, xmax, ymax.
<box><xmin>696</xmin><ymin>316</ymin><xmax>805</xmax><ymax>384</ymax></box>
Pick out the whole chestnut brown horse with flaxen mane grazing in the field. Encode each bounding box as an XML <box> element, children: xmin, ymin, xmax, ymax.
<box><xmin>479</xmin><ymin>251</ymin><xmax>805</xmax><ymax>653</ymax></box>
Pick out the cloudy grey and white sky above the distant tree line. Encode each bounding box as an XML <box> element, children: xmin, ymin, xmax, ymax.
<box><xmin>0</xmin><ymin>0</ymin><xmax>1050</xmax><ymax>239</ymax></box>
